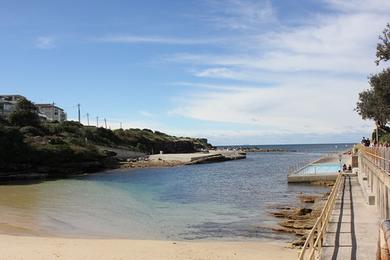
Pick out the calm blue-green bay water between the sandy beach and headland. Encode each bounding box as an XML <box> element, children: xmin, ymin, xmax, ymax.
<box><xmin>0</xmin><ymin>143</ymin><xmax>354</xmax><ymax>240</ymax></box>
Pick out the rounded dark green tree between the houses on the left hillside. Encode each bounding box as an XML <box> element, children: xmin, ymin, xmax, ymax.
<box><xmin>9</xmin><ymin>98</ymin><xmax>40</xmax><ymax>126</ymax></box>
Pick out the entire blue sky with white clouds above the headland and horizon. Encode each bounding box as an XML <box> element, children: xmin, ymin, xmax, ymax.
<box><xmin>0</xmin><ymin>0</ymin><xmax>390</xmax><ymax>145</ymax></box>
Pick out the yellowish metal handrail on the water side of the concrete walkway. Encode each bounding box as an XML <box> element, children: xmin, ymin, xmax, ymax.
<box><xmin>298</xmin><ymin>173</ymin><xmax>343</xmax><ymax>260</ymax></box>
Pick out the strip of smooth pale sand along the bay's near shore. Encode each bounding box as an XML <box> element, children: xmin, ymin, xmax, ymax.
<box><xmin>0</xmin><ymin>235</ymin><xmax>297</xmax><ymax>260</ymax></box>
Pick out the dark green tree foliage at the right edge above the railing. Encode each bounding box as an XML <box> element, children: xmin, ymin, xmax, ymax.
<box><xmin>355</xmin><ymin>24</ymin><xmax>390</xmax><ymax>143</ymax></box>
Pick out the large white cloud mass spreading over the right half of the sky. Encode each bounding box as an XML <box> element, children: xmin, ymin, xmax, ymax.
<box><xmin>166</xmin><ymin>0</ymin><xmax>390</xmax><ymax>141</ymax></box>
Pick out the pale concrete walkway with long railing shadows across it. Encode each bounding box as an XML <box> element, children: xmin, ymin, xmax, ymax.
<box><xmin>321</xmin><ymin>175</ymin><xmax>379</xmax><ymax>260</ymax></box>
